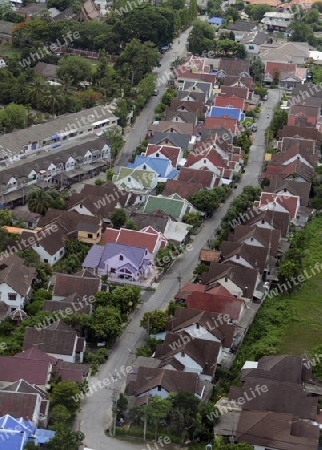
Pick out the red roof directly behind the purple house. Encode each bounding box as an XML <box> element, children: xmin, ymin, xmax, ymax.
<box><xmin>102</xmin><ymin>228</ymin><xmax>166</xmax><ymax>253</ymax></box>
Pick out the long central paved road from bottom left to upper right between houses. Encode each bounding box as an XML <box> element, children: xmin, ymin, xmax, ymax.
<box><xmin>76</xmin><ymin>90</ymin><xmax>279</xmax><ymax>450</ymax></box>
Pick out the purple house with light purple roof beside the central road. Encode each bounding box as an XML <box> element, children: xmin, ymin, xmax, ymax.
<box><xmin>83</xmin><ymin>243</ymin><xmax>153</xmax><ymax>281</ymax></box>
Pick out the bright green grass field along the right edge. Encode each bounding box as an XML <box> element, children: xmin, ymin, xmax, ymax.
<box><xmin>279</xmin><ymin>217</ymin><xmax>322</xmax><ymax>356</ymax></box>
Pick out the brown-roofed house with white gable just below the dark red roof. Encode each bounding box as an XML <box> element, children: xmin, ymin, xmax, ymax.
<box><xmin>166</xmin><ymin>307</ymin><xmax>236</xmax><ymax>353</ymax></box>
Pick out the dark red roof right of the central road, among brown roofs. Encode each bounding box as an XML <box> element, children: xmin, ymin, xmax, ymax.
<box><xmin>186</xmin><ymin>292</ymin><xmax>243</xmax><ymax>320</ymax></box>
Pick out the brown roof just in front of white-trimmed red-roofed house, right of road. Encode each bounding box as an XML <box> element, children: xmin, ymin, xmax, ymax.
<box><xmin>241</xmin><ymin>208</ymin><xmax>290</xmax><ymax>237</ymax></box>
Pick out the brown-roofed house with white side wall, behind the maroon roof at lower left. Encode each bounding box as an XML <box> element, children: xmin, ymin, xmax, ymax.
<box><xmin>22</xmin><ymin>320</ymin><xmax>86</xmax><ymax>363</ymax></box>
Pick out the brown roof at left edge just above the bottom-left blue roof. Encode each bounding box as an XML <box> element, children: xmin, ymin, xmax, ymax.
<box><xmin>0</xmin><ymin>391</ymin><xmax>38</xmax><ymax>422</ymax></box>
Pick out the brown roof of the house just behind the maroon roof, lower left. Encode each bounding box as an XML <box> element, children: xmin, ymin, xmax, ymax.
<box><xmin>22</xmin><ymin>320</ymin><xmax>78</xmax><ymax>355</ymax></box>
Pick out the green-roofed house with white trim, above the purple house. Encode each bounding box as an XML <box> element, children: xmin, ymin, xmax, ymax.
<box><xmin>140</xmin><ymin>194</ymin><xmax>195</xmax><ymax>220</ymax></box>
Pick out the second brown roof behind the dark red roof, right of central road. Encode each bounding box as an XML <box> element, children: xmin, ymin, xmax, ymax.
<box><xmin>220</xmin><ymin>241</ymin><xmax>268</xmax><ymax>273</ymax></box>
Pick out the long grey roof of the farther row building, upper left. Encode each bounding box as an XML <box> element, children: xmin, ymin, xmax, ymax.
<box><xmin>0</xmin><ymin>106</ymin><xmax>117</xmax><ymax>157</ymax></box>
